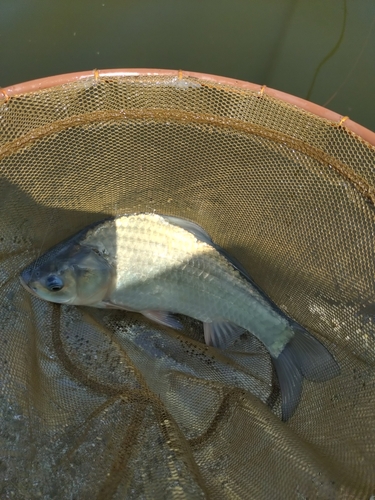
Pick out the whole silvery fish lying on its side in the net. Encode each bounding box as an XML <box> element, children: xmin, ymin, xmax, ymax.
<box><xmin>20</xmin><ymin>213</ymin><xmax>340</xmax><ymax>421</ymax></box>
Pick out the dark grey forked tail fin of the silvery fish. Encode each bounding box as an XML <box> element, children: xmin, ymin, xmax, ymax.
<box><xmin>272</xmin><ymin>323</ymin><xmax>340</xmax><ymax>421</ymax></box>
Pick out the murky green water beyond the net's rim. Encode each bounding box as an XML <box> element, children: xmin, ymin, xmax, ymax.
<box><xmin>0</xmin><ymin>0</ymin><xmax>375</xmax><ymax>130</ymax></box>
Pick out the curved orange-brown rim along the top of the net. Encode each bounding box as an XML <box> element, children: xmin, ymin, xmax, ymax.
<box><xmin>0</xmin><ymin>68</ymin><xmax>375</xmax><ymax>146</ymax></box>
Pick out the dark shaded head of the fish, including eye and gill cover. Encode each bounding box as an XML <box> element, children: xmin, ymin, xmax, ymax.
<box><xmin>20</xmin><ymin>243</ymin><xmax>114</xmax><ymax>305</ymax></box>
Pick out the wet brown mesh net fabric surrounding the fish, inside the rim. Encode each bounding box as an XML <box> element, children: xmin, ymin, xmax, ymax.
<box><xmin>0</xmin><ymin>76</ymin><xmax>375</xmax><ymax>499</ymax></box>
